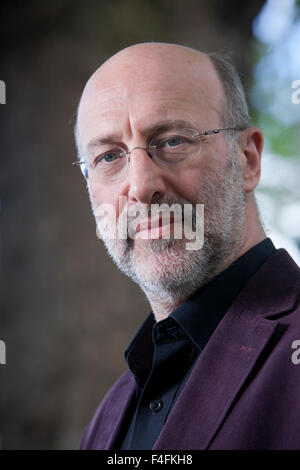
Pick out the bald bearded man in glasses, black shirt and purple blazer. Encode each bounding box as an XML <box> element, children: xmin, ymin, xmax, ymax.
<box><xmin>72</xmin><ymin>43</ymin><xmax>300</xmax><ymax>450</ymax></box>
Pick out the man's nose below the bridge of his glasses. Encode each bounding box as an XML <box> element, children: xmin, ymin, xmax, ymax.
<box><xmin>127</xmin><ymin>147</ymin><xmax>166</xmax><ymax>205</ymax></box>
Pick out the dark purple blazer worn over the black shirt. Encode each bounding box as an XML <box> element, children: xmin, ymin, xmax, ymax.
<box><xmin>80</xmin><ymin>249</ymin><xmax>300</xmax><ymax>450</ymax></box>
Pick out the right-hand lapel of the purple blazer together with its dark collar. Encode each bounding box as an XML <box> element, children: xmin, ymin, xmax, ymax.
<box><xmin>153</xmin><ymin>249</ymin><xmax>299</xmax><ymax>449</ymax></box>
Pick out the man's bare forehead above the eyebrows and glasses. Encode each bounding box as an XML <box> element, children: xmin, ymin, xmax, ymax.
<box><xmin>78</xmin><ymin>51</ymin><xmax>223</xmax><ymax>146</ymax></box>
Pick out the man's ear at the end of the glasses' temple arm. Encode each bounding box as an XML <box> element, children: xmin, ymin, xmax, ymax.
<box><xmin>239</xmin><ymin>127</ymin><xmax>264</xmax><ymax>193</ymax></box>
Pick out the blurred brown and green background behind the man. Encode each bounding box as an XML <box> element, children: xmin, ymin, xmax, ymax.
<box><xmin>0</xmin><ymin>0</ymin><xmax>300</xmax><ymax>449</ymax></box>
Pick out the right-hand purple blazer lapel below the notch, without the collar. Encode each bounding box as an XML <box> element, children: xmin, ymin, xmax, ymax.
<box><xmin>153</xmin><ymin>302</ymin><xmax>277</xmax><ymax>450</ymax></box>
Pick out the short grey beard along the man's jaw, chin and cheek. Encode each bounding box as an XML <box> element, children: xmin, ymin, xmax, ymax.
<box><xmin>92</xmin><ymin>152</ymin><xmax>246</xmax><ymax>304</ymax></box>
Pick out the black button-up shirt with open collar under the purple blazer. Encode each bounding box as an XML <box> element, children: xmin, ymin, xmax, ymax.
<box><xmin>117</xmin><ymin>238</ymin><xmax>276</xmax><ymax>450</ymax></box>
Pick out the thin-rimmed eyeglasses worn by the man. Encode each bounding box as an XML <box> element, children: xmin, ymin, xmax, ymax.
<box><xmin>73</xmin><ymin>127</ymin><xmax>244</xmax><ymax>184</ymax></box>
